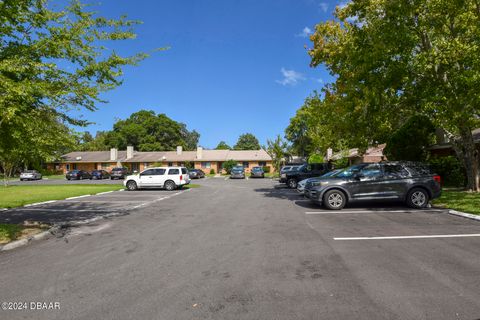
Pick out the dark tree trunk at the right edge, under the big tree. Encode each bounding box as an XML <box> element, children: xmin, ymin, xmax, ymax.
<box><xmin>455</xmin><ymin>128</ymin><xmax>480</xmax><ymax>192</ymax></box>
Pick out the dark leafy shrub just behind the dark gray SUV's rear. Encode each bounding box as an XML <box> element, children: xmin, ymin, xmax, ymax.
<box><xmin>428</xmin><ymin>156</ymin><xmax>466</xmax><ymax>187</ymax></box>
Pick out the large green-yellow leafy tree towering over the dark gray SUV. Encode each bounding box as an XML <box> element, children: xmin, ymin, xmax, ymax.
<box><xmin>309</xmin><ymin>0</ymin><xmax>480</xmax><ymax>191</ymax></box>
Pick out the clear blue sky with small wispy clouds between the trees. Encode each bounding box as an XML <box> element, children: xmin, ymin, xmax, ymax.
<box><xmin>77</xmin><ymin>0</ymin><xmax>338</xmax><ymax>148</ymax></box>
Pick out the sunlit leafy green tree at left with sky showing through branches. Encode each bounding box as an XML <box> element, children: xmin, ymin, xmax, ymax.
<box><xmin>0</xmin><ymin>0</ymin><xmax>152</xmax><ymax>184</ymax></box>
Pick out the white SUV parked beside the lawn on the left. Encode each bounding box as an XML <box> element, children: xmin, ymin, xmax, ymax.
<box><xmin>123</xmin><ymin>167</ymin><xmax>190</xmax><ymax>191</ymax></box>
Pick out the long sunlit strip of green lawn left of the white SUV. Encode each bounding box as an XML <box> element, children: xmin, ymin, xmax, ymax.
<box><xmin>0</xmin><ymin>184</ymin><xmax>121</xmax><ymax>208</ymax></box>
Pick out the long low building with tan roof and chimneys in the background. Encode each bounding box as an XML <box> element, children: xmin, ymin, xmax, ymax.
<box><xmin>47</xmin><ymin>146</ymin><xmax>274</xmax><ymax>173</ymax></box>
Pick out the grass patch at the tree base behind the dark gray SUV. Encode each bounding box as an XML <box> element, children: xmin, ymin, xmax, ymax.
<box><xmin>433</xmin><ymin>190</ymin><xmax>480</xmax><ymax>215</ymax></box>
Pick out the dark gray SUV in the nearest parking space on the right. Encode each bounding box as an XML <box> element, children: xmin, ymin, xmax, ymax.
<box><xmin>305</xmin><ymin>162</ymin><xmax>441</xmax><ymax>210</ymax></box>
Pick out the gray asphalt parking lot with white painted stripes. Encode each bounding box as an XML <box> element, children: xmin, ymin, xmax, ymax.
<box><xmin>0</xmin><ymin>179</ymin><xmax>480</xmax><ymax>320</ymax></box>
